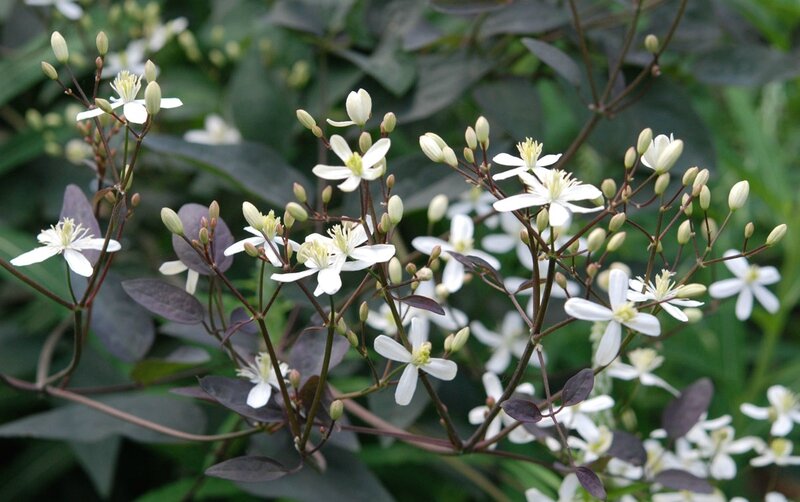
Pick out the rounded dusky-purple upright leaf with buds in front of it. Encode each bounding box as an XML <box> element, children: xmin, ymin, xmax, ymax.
<box><xmin>172</xmin><ymin>203</ymin><xmax>233</xmax><ymax>275</ymax></box>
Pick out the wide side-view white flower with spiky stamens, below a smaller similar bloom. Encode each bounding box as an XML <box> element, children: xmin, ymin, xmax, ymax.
<box><xmin>493</xmin><ymin>169</ymin><xmax>603</xmax><ymax>227</ymax></box>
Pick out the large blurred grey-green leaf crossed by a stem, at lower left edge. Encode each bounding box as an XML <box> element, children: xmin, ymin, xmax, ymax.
<box><xmin>0</xmin><ymin>394</ymin><xmax>206</xmax><ymax>443</ymax></box>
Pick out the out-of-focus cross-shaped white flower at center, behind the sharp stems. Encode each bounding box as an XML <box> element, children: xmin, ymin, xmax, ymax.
<box><xmin>411</xmin><ymin>214</ymin><xmax>500</xmax><ymax>293</ymax></box>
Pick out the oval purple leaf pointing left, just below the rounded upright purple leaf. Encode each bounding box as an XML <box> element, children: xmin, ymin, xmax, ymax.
<box><xmin>122</xmin><ymin>279</ymin><xmax>205</xmax><ymax>324</ymax></box>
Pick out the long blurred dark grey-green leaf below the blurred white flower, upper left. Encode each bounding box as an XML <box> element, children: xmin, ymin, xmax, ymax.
<box><xmin>145</xmin><ymin>134</ymin><xmax>311</xmax><ymax>207</ymax></box>
